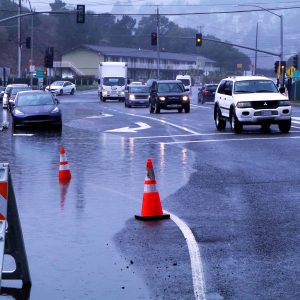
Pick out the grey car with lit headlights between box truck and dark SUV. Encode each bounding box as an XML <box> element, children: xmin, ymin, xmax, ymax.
<box><xmin>125</xmin><ymin>84</ymin><xmax>150</xmax><ymax>107</ymax></box>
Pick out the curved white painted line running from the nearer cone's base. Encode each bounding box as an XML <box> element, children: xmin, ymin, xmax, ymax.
<box><xmin>164</xmin><ymin>210</ymin><xmax>206</xmax><ymax>300</ymax></box>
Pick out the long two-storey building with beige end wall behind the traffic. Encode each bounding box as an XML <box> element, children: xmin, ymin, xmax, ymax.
<box><xmin>54</xmin><ymin>45</ymin><xmax>219</xmax><ymax>81</ymax></box>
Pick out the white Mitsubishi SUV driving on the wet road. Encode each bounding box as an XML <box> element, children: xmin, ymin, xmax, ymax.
<box><xmin>214</xmin><ymin>76</ymin><xmax>292</xmax><ymax>133</ymax></box>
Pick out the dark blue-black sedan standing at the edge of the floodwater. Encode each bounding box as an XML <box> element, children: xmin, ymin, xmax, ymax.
<box><xmin>12</xmin><ymin>90</ymin><xmax>62</xmax><ymax>130</ymax></box>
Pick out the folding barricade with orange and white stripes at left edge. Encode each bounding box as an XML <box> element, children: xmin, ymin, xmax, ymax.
<box><xmin>0</xmin><ymin>163</ymin><xmax>31</xmax><ymax>291</ymax></box>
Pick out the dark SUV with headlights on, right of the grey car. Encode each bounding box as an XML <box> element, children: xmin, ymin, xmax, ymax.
<box><xmin>149</xmin><ymin>80</ymin><xmax>190</xmax><ymax>114</ymax></box>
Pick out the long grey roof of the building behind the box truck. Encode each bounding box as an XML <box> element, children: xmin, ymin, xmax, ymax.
<box><xmin>77</xmin><ymin>44</ymin><xmax>215</xmax><ymax>63</ymax></box>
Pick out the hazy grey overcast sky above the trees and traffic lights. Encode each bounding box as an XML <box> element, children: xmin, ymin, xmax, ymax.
<box><xmin>22</xmin><ymin>0</ymin><xmax>300</xmax><ymax>68</ymax></box>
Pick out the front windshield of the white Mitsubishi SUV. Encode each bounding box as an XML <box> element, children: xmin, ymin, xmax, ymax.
<box><xmin>234</xmin><ymin>80</ymin><xmax>278</xmax><ymax>94</ymax></box>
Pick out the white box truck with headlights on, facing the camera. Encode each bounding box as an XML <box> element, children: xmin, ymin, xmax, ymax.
<box><xmin>98</xmin><ymin>62</ymin><xmax>127</xmax><ymax>102</ymax></box>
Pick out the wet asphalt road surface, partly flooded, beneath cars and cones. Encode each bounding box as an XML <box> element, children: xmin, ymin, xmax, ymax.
<box><xmin>0</xmin><ymin>91</ymin><xmax>300</xmax><ymax>299</ymax></box>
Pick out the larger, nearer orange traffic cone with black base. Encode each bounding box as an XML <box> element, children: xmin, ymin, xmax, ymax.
<box><xmin>135</xmin><ymin>159</ymin><xmax>170</xmax><ymax>221</ymax></box>
